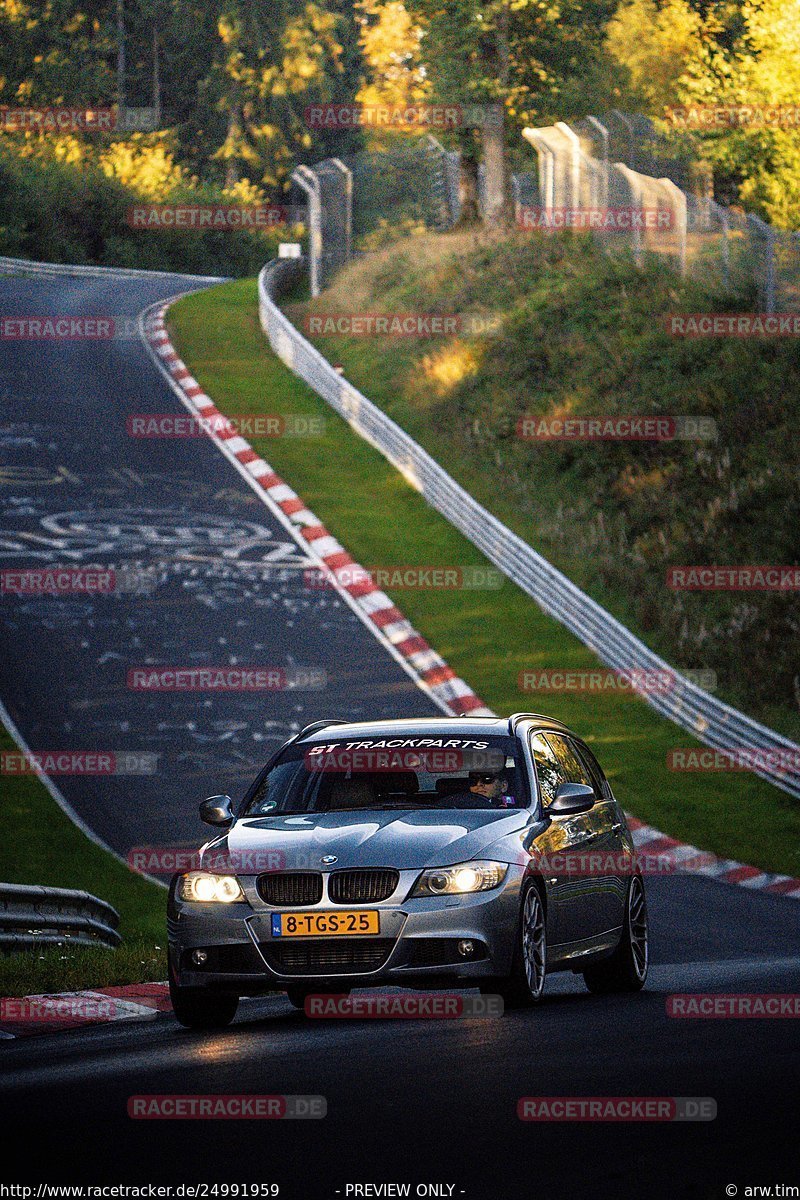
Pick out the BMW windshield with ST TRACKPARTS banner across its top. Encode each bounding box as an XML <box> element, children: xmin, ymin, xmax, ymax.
<box><xmin>246</xmin><ymin>734</ymin><xmax>529</xmax><ymax>816</ymax></box>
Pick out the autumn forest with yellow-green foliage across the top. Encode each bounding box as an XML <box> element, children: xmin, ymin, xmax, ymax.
<box><xmin>0</xmin><ymin>0</ymin><xmax>800</xmax><ymax>229</ymax></box>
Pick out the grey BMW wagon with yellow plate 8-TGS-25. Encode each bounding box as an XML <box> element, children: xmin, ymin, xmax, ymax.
<box><xmin>168</xmin><ymin>713</ymin><xmax>648</xmax><ymax>1027</ymax></box>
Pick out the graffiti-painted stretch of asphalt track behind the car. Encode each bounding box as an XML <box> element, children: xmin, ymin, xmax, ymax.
<box><xmin>0</xmin><ymin>277</ymin><xmax>439</xmax><ymax>856</ymax></box>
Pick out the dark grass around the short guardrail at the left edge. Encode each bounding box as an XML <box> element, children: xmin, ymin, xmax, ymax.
<box><xmin>0</xmin><ymin>726</ymin><xmax>167</xmax><ymax>996</ymax></box>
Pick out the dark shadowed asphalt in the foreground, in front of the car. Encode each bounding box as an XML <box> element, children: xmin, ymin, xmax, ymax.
<box><xmin>0</xmin><ymin>880</ymin><xmax>800</xmax><ymax>1200</ymax></box>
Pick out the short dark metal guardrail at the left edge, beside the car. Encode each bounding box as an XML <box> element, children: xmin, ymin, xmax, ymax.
<box><xmin>0</xmin><ymin>883</ymin><xmax>122</xmax><ymax>950</ymax></box>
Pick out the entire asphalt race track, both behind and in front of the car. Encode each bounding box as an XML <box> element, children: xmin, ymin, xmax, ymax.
<box><xmin>0</xmin><ymin>272</ymin><xmax>800</xmax><ymax>1200</ymax></box>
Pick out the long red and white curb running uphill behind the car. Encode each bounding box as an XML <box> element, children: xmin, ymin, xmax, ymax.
<box><xmin>144</xmin><ymin>301</ymin><xmax>494</xmax><ymax>716</ymax></box>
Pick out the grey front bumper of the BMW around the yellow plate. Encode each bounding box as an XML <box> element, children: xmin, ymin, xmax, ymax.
<box><xmin>168</xmin><ymin>866</ymin><xmax>523</xmax><ymax>995</ymax></box>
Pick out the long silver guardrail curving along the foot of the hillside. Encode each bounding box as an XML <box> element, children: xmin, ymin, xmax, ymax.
<box><xmin>258</xmin><ymin>259</ymin><xmax>800</xmax><ymax>797</ymax></box>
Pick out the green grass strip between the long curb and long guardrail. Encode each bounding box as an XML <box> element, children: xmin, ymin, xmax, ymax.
<box><xmin>169</xmin><ymin>268</ymin><xmax>800</xmax><ymax>875</ymax></box>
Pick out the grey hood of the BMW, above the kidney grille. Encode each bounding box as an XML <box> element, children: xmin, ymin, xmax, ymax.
<box><xmin>206</xmin><ymin>809</ymin><xmax>530</xmax><ymax>875</ymax></box>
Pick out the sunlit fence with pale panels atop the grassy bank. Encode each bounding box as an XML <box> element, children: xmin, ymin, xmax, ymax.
<box><xmin>515</xmin><ymin>112</ymin><xmax>800</xmax><ymax>313</ymax></box>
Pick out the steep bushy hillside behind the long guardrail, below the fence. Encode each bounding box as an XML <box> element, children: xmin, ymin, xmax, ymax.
<box><xmin>291</xmin><ymin>223</ymin><xmax>800</xmax><ymax>737</ymax></box>
